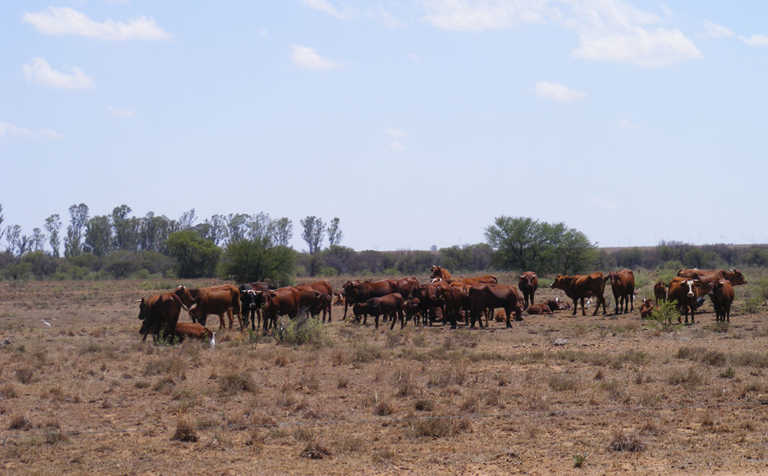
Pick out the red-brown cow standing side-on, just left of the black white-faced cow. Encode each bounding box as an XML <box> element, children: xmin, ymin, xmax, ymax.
<box><xmin>175</xmin><ymin>284</ymin><xmax>244</xmax><ymax>330</ymax></box>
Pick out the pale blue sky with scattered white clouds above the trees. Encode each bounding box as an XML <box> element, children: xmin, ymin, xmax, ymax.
<box><xmin>0</xmin><ymin>0</ymin><xmax>768</xmax><ymax>250</ymax></box>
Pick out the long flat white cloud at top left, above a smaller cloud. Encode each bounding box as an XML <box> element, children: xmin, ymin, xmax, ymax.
<box><xmin>23</xmin><ymin>7</ymin><xmax>171</xmax><ymax>40</ymax></box>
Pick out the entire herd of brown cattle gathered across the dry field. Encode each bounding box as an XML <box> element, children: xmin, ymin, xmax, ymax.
<box><xmin>139</xmin><ymin>266</ymin><xmax>746</xmax><ymax>340</ymax></box>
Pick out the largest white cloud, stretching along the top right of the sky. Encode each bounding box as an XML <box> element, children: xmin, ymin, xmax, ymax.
<box><xmin>422</xmin><ymin>0</ymin><xmax>701</xmax><ymax>67</ymax></box>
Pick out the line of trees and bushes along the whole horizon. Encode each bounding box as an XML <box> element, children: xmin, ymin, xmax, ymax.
<box><xmin>0</xmin><ymin>203</ymin><xmax>768</xmax><ymax>284</ymax></box>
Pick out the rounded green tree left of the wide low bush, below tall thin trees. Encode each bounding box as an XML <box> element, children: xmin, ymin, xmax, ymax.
<box><xmin>167</xmin><ymin>230</ymin><xmax>221</xmax><ymax>278</ymax></box>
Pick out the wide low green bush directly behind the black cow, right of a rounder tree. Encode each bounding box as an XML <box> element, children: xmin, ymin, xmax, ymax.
<box><xmin>221</xmin><ymin>236</ymin><xmax>296</xmax><ymax>284</ymax></box>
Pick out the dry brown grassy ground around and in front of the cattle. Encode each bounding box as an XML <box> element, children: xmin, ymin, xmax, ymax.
<box><xmin>0</xmin><ymin>280</ymin><xmax>768</xmax><ymax>474</ymax></box>
